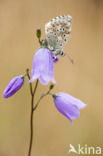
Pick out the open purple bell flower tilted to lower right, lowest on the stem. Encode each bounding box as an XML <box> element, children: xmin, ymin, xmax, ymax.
<box><xmin>53</xmin><ymin>93</ymin><xmax>86</xmax><ymax>123</ymax></box>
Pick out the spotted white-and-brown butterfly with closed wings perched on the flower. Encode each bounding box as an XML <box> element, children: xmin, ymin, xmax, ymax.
<box><xmin>45</xmin><ymin>15</ymin><xmax>72</xmax><ymax>61</ymax></box>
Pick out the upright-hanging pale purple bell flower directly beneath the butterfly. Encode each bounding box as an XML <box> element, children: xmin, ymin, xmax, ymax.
<box><xmin>29</xmin><ymin>48</ymin><xmax>56</xmax><ymax>85</ymax></box>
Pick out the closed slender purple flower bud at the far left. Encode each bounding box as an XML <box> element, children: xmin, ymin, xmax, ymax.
<box><xmin>3</xmin><ymin>75</ymin><xmax>24</xmax><ymax>98</ymax></box>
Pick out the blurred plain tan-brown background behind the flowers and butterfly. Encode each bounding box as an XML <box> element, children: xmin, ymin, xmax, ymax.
<box><xmin>0</xmin><ymin>0</ymin><xmax>103</xmax><ymax>156</ymax></box>
